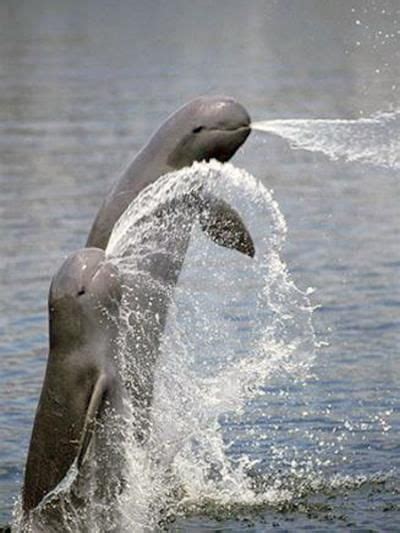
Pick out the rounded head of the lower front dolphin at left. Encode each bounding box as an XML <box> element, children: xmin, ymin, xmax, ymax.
<box><xmin>49</xmin><ymin>248</ymin><xmax>121</xmax><ymax>351</ymax></box>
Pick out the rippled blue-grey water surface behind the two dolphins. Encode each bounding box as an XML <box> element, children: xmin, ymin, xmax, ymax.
<box><xmin>0</xmin><ymin>0</ymin><xmax>400</xmax><ymax>531</ymax></box>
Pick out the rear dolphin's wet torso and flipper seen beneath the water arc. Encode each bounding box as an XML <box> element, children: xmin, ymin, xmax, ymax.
<box><xmin>115</xmin><ymin>192</ymin><xmax>255</xmax><ymax>442</ymax></box>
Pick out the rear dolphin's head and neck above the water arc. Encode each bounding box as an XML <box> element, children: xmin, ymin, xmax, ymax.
<box><xmin>86</xmin><ymin>96</ymin><xmax>251</xmax><ymax>249</ymax></box>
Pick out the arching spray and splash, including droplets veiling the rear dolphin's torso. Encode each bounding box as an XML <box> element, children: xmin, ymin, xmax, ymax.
<box><xmin>12</xmin><ymin>162</ymin><xmax>315</xmax><ymax>532</ymax></box>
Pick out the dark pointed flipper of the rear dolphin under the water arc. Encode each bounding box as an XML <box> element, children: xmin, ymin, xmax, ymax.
<box><xmin>199</xmin><ymin>195</ymin><xmax>255</xmax><ymax>257</ymax></box>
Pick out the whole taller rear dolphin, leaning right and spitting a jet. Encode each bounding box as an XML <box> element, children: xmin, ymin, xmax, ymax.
<box><xmin>87</xmin><ymin>96</ymin><xmax>255</xmax><ymax>438</ymax></box>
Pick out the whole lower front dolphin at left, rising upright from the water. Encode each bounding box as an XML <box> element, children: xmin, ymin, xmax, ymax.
<box><xmin>22</xmin><ymin>248</ymin><xmax>123</xmax><ymax>532</ymax></box>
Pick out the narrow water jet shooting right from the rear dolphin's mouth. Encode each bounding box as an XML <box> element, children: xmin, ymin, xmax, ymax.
<box><xmin>252</xmin><ymin>111</ymin><xmax>400</xmax><ymax>169</ymax></box>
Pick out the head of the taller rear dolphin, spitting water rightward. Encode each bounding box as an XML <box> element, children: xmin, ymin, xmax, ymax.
<box><xmin>154</xmin><ymin>96</ymin><xmax>251</xmax><ymax>169</ymax></box>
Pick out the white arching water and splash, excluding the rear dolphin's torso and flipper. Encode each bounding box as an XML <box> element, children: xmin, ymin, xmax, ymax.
<box><xmin>106</xmin><ymin>162</ymin><xmax>315</xmax><ymax>529</ymax></box>
